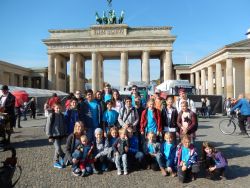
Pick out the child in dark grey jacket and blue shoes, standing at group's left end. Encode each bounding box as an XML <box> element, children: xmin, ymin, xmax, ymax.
<box><xmin>46</xmin><ymin>103</ymin><xmax>67</xmax><ymax>168</ymax></box>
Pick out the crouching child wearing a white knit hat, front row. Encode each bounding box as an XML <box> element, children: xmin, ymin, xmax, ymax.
<box><xmin>94</xmin><ymin>128</ymin><xmax>108</xmax><ymax>171</ymax></box>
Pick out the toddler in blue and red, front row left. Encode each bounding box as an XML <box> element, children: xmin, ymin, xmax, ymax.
<box><xmin>72</xmin><ymin>135</ymin><xmax>98</xmax><ymax>176</ymax></box>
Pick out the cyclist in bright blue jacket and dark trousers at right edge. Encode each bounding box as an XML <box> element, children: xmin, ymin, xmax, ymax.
<box><xmin>230</xmin><ymin>94</ymin><xmax>250</xmax><ymax>135</ymax></box>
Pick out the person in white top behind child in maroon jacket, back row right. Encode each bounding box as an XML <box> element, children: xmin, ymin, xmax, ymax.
<box><xmin>175</xmin><ymin>89</ymin><xmax>196</xmax><ymax>113</ymax></box>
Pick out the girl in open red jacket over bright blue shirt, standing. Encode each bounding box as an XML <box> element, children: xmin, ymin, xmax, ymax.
<box><xmin>140</xmin><ymin>99</ymin><xmax>162</xmax><ymax>140</ymax></box>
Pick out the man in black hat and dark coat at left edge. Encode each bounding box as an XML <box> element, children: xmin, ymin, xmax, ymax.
<box><xmin>0</xmin><ymin>85</ymin><xmax>16</xmax><ymax>142</ymax></box>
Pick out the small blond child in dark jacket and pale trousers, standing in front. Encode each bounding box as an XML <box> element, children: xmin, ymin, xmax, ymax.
<box><xmin>113</xmin><ymin>128</ymin><xmax>129</xmax><ymax>175</ymax></box>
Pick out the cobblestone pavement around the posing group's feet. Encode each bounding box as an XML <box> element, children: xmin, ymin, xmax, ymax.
<box><xmin>0</xmin><ymin>116</ymin><xmax>250</xmax><ymax>188</ymax></box>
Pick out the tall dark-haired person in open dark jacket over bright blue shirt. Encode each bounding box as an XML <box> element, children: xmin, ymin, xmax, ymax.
<box><xmin>79</xmin><ymin>89</ymin><xmax>102</xmax><ymax>141</ymax></box>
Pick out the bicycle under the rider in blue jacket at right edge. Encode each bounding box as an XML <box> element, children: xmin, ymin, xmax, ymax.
<box><xmin>219</xmin><ymin>115</ymin><xmax>249</xmax><ymax>135</ymax></box>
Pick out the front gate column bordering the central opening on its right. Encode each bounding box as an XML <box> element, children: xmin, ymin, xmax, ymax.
<box><xmin>120</xmin><ymin>51</ymin><xmax>128</xmax><ymax>88</ymax></box>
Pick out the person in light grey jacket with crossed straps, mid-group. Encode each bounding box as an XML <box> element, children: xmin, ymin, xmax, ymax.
<box><xmin>118</xmin><ymin>97</ymin><xmax>139</xmax><ymax>131</ymax></box>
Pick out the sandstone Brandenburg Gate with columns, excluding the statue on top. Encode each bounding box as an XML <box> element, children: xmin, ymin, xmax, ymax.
<box><xmin>43</xmin><ymin>24</ymin><xmax>176</xmax><ymax>92</ymax></box>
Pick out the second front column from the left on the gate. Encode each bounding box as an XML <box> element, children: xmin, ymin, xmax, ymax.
<box><xmin>69</xmin><ymin>53</ymin><xmax>77</xmax><ymax>93</ymax></box>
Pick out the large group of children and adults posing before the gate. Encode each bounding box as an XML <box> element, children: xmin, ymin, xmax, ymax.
<box><xmin>46</xmin><ymin>84</ymin><xmax>227</xmax><ymax>182</ymax></box>
